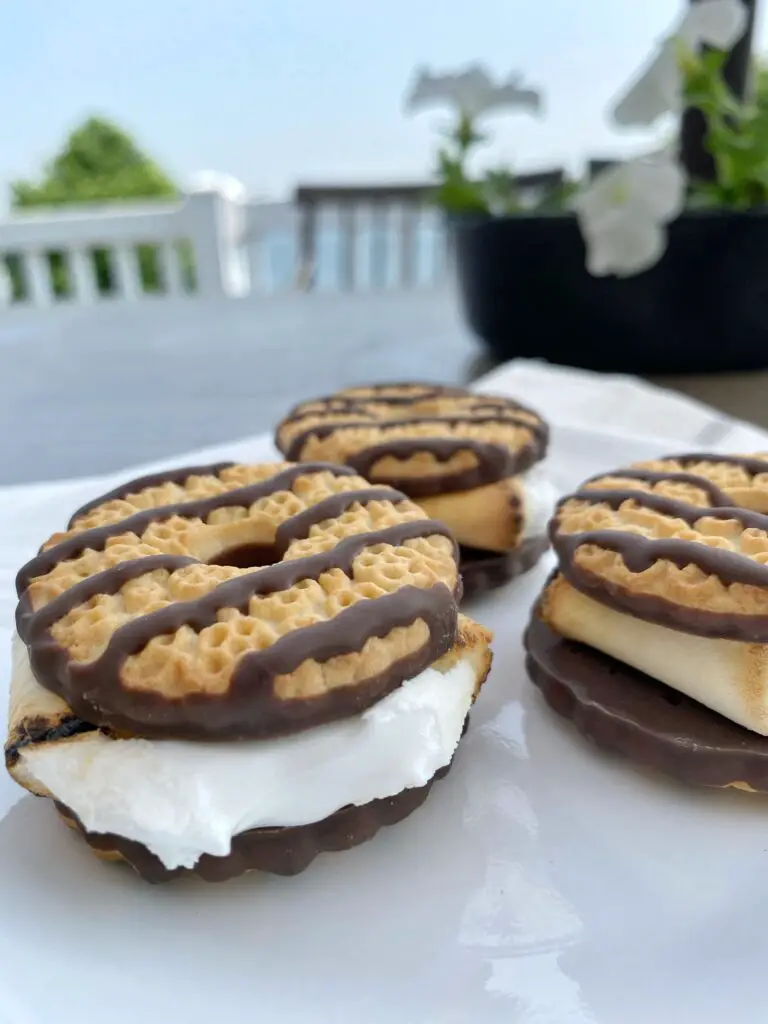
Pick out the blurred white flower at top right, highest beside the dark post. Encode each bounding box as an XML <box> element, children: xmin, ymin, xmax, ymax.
<box><xmin>613</xmin><ymin>0</ymin><xmax>746</xmax><ymax>127</ymax></box>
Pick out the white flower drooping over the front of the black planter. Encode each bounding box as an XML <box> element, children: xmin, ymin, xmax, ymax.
<box><xmin>572</xmin><ymin>148</ymin><xmax>686</xmax><ymax>278</ymax></box>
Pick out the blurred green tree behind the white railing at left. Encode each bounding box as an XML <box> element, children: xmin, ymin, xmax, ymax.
<box><xmin>6</xmin><ymin>118</ymin><xmax>190</xmax><ymax>298</ymax></box>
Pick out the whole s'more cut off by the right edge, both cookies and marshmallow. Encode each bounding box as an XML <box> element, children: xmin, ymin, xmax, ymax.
<box><xmin>526</xmin><ymin>453</ymin><xmax>768</xmax><ymax>790</ymax></box>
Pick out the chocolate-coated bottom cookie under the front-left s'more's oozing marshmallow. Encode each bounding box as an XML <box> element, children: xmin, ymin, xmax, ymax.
<box><xmin>56</xmin><ymin>765</ymin><xmax>451</xmax><ymax>883</ymax></box>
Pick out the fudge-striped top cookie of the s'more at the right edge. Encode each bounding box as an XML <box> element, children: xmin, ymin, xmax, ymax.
<box><xmin>551</xmin><ymin>454</ymin><xmax>768</xmax><ymax>643</ymax></box>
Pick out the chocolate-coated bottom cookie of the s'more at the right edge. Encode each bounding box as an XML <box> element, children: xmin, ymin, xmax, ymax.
<box><xmin>524</xmin><ymin>611</ymin><xmax>768</xmax><ymax>792</ymax></box>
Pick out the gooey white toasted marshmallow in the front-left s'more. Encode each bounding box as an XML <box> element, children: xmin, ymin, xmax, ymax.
<box><xmin>10</xmin><ymin>616</ymin><xmax>490</xmax><ymax>869</ymax></box>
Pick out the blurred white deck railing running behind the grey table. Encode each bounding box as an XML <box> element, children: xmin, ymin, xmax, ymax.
<box><xmin>0</xmin><ymin>178</ymin><xmax>445</xmax><ymax>315</ymax></box>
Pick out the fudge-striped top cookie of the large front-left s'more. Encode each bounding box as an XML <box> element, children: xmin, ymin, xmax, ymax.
<box><xmin>16</xmin><ymin>463</ymin><xmax>460</xmax><ymax>738</ymax></box>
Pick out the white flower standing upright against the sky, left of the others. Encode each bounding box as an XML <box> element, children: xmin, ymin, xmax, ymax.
<box><xmin>406</xmin><ymin>65</ymin><xmax>542</xmax><ymax>120</ymax></box>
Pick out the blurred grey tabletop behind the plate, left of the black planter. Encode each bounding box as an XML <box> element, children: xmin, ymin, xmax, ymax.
<box><xmin>0</xmin><ymin>292</ymin><xmax>479</xmax><ymax>485</ymax></box>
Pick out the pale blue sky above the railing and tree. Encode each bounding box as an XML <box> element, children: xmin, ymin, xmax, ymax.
<box><xmin>0</xmin><ymin>0</ymin><xmax>768</xmax><ymax>205</ymax></box>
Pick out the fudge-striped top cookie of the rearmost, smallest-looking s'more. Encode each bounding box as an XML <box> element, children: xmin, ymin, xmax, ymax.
<box><xmin>275</xmin><ymin>384</ymin><xmax>549</xmax><ymax>498</ymax></box>
